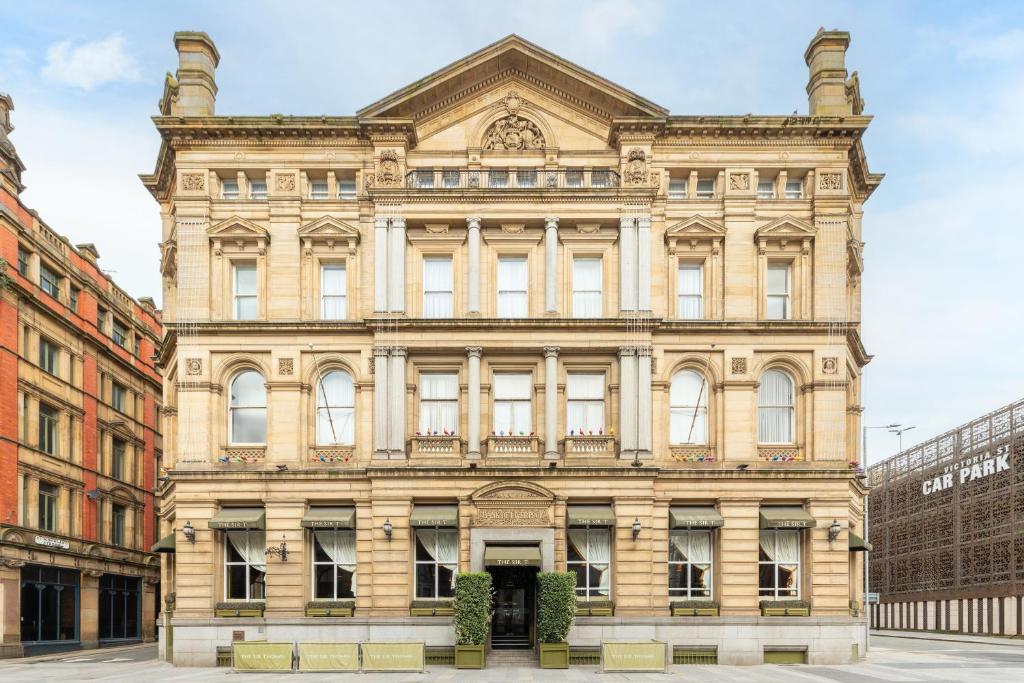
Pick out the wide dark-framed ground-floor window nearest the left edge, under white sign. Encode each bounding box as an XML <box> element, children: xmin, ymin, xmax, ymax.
<box><xmin>22</xmin><ymin>565</ymin><xmax>80</xmax><ymax>643</ymax></box>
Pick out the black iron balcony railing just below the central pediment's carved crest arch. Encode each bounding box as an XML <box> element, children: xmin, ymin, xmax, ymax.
<box><xmin>406</xmin><ymin>168</ymin><xmax>620</xmax><ymax>190</ymax></box>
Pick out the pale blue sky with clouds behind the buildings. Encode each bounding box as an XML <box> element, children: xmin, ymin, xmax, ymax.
<box><xmin>0</xmin><ymin>0</ymin><xmax>1024</xmax><ymax>462</ymax></box>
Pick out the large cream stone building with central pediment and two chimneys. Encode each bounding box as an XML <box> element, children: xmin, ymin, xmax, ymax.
<box><xmin>142</xmin><ymin>31</ymin><xmax>882</xmax><ymax>666</ymax></box>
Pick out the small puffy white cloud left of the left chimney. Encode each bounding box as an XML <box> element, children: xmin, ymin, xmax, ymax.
<box><xmin>43</xmin><ymin>34</ymin><xmax>140</xmax><ymax>90</ymax></box>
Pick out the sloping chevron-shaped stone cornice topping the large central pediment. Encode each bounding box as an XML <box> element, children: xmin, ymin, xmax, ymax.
<box><xmin>357</xmin><ymin>35</ymin><xmax>669</xmax><ymax>119</ymax></box>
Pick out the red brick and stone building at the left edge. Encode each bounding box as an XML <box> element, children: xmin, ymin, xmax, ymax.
<box><xmin>0</xmin><ymin>94</ymin><xmax>162</xmax><ymax>656</ymax></box>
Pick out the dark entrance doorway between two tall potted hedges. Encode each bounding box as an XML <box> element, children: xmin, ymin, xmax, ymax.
<box><xmin>487</xmin><ymin>566</ymin><xmax>538</xmax><ymax>650</ymax></box>
